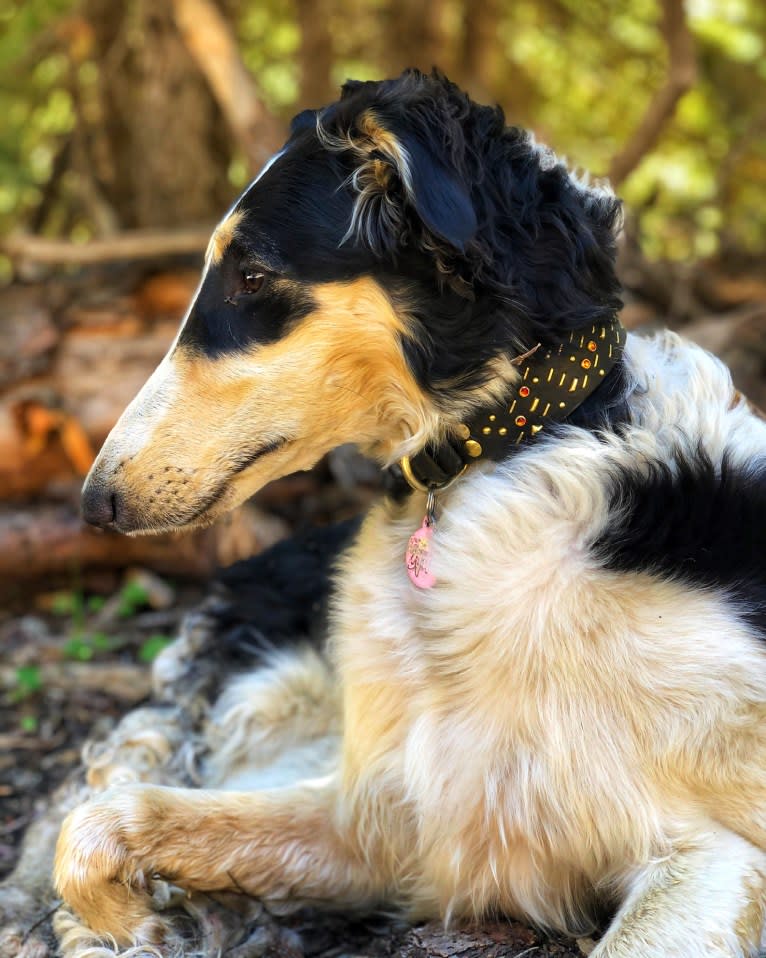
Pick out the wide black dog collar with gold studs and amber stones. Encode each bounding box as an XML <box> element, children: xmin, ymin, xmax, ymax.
<box><xmin>399</xmin><ymin>316</ymin><xmax>626</xmax><ymax>492</ymax></box>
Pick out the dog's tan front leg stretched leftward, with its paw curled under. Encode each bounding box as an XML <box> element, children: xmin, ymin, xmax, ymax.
<box><xmin>54</xmin><ymin>780</ymin><xmax>375</xmax><ymax>944</ymax></box>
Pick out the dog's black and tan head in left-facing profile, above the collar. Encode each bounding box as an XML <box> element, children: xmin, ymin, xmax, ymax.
<box><xmin>83</xmin><ymin>71</ymin><xmax>619</xmax><ymax>532</ymax></box>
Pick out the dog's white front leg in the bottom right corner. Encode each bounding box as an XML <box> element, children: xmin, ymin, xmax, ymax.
<box><xmin>591</xmin><ymin>824</ymin><xmax>766</xmax><ymax>958</ymax></box>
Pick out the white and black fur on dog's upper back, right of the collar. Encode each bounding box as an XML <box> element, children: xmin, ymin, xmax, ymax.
<box><xmin>592</xmin><ymin>333</ymin><xmax>766</xmax><ymax>633</ymax></box>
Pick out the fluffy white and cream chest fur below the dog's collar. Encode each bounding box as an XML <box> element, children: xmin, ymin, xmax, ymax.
<box><xmin>334</xmin><ymin>336</ymin><xmax>764</xmax><ymax>927</ymax></box>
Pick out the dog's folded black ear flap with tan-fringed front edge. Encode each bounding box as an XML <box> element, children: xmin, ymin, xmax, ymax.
<box><xmin>356</xmin><ymin>111</ymin><xmax>477</xmax><ymax>253</ymax></box>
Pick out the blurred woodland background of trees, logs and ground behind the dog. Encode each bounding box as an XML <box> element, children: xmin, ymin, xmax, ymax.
<box><xmin>0</xmin><ymin>0</ymin><xmax>766</xmax><ymax>871</ymax></box>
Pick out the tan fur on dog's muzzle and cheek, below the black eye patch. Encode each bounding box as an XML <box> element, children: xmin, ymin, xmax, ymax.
<box><xmin>82</xmin><ymin>278</ymin><xmax>436</xmax><ymax>533</ymax></box>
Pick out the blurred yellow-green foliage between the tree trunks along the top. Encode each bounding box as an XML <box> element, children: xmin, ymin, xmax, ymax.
<box><xmin>0</xmin><ymin>0</ymin><xmax>766</xmax><ymax>258</ymax></box>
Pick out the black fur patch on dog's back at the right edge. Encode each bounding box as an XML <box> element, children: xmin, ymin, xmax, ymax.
<box><xmin>593</xmin><ymin>452</ymin><xmax>766</xmax><ymax>636</ymax></box>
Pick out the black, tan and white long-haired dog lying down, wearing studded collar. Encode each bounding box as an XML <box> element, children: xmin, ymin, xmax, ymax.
<box><xmin>55</xmin><ymin>71</ymin><xmax>766</xmax><ymax>958</ymax></box>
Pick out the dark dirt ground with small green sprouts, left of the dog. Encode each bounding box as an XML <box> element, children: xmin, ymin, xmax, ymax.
<box><xmin>0</xmin><ymin>571</ymin><xmax>204</xmax><ymax>878</ymax></box>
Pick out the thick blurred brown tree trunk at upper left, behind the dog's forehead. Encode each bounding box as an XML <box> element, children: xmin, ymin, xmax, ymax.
<box><xmin>76</xmin><ymin>0</ymin><xmax>233</xmax><ymax>228</ymax></box>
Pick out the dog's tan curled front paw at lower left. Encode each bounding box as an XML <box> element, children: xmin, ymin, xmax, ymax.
<box><xmin>54</xmin><ymin>785</ymin><xmax>172</xmax><ymax>945</ymax></box>
